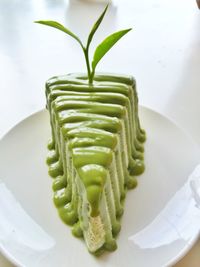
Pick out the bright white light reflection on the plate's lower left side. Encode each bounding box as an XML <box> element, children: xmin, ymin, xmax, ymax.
<box><xmin>0</xmin><ymin>181</ymin><xmax>55</xmax><ymax>265</ymax></box>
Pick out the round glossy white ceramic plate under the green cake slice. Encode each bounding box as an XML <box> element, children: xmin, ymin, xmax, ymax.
<box><xmin>0</xmin><ymin>108</ymin><xmax>200</xmax><ymax>267</ymax></box>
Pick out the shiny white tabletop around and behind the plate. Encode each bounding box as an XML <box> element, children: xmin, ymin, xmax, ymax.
<box><xmin>0</xmin><ymin>0</ymin><xmax>200</xmax><ymax>267</ymax></box>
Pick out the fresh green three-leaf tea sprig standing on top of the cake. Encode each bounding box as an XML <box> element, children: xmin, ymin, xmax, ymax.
<box><xmin>35</xmin><ymin>5</ymin><xmax>131</xmax><ymax>85</ymax></box>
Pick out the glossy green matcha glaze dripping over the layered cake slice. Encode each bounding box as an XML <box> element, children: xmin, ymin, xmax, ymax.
<box><xmin>46</xmin><ymin>74</ymin><xmax>145</xmax><ymax>254</ymax></box>
